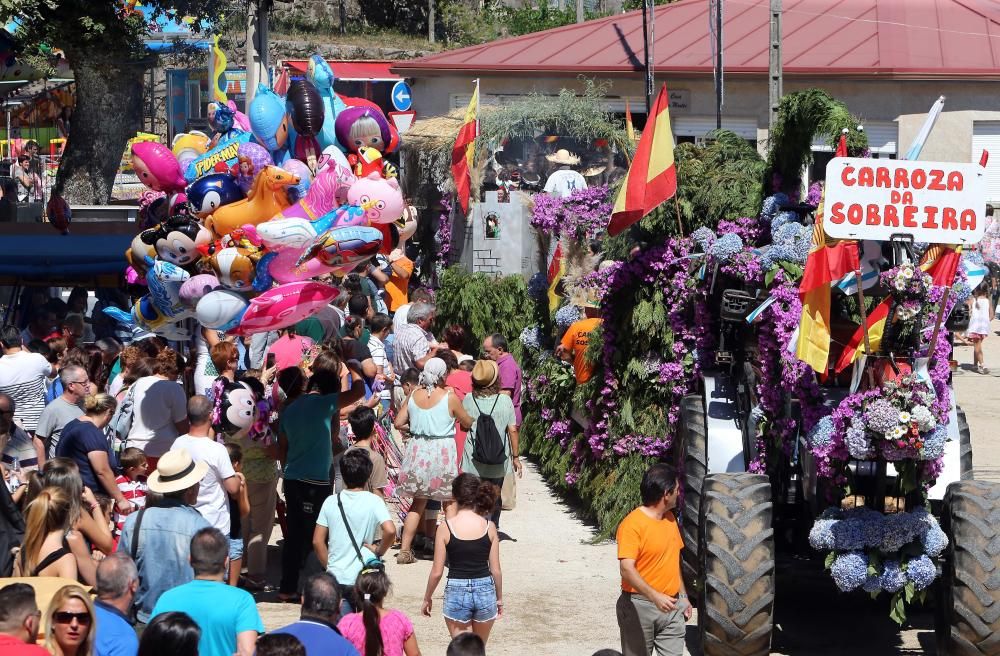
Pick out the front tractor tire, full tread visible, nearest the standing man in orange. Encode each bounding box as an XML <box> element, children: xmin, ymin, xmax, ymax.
<box><xmin>698</xmin><ymin>473</ymin><xmax>775</xmax><ymax>656</ymax></box>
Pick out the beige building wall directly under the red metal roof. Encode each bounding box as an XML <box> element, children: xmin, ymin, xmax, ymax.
<box><xmin>413</xmin><ymin>74</ymin><xmax>1000</xmax><ymax>162</ymax></box>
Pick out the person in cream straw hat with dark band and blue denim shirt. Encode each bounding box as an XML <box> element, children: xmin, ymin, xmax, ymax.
<box><xmin>118</xmin><ymin>449</ymin><xmax>210</xmax><ymax>624</ymax></box>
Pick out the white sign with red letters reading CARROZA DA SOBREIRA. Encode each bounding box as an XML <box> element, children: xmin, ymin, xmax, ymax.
<box><xmin>823</xmin><ymin>157</ymin><xmax>986</xmax><ymax>244</ymax></box>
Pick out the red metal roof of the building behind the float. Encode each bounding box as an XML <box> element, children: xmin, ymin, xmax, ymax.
<box><xmin>392</xmin><ymin>0</ymin><xmax>1000</xmax><ymax>78</ymax></box>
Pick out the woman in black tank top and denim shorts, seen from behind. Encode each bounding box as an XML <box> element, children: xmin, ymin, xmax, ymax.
<box><xmin>421</xmin><ymin>474</ymin><xmax>503</xmax><ymax>642</ymax></box>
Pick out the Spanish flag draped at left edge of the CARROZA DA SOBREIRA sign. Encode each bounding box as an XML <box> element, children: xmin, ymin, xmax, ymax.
<box><xmin>796</xmin><ymin>203</ymin><xmax>861</xmax><ymax>374</ymax></box>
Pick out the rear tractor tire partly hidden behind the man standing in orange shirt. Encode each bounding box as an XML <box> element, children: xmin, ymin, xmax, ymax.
<box><xmin>679</xmin><ymin>394</ymin><xmax>708</xmax><ymax>603</ymax></box>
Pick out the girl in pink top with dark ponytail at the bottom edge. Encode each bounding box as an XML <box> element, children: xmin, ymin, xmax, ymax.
<box><xmin>337</xmin><ymin>561</ymin><xmax>420</xmax><ymax>656</ymax></box>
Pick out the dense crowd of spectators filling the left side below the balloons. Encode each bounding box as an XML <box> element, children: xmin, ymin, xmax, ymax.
<box><xmin>0</xmin><ymin>270</ymin><xmax>536</xmax><ymax>656</ymax></box>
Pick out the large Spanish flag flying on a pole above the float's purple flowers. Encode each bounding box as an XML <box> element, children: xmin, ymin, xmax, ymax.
<box><xmin>608</xmin><ymin>84</ymin><xmax>677</xmax><ymax>237</ymax></box>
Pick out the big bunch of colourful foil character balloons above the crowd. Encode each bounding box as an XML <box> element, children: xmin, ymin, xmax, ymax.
<box><xmin>115</xmin><ymin>56</ymin><xmax>415</xmax><ymax>339</ymax></box>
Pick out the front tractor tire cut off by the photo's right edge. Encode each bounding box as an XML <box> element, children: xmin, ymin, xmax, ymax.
<box><xmin>935</xmin><ymin>481</ymin><xmax>1000</xmax><ymax>656</ymax></box>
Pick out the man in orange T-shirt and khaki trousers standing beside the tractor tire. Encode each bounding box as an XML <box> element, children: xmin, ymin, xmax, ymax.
<box><xmin>617</xmin><ymin>464</ymin><xmax>691</xmax><ymax>656</ymax></box>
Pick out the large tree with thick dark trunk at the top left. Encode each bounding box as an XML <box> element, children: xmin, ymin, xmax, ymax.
<box><xmin>0</xmin><ymin>0</ymin><xmax>242</xmax><ymax>204</ymax></box>
